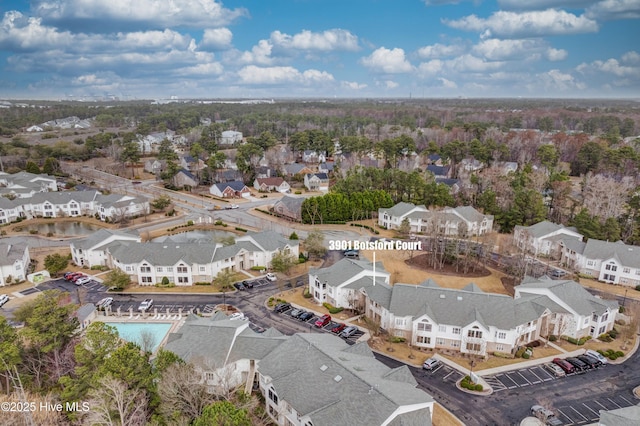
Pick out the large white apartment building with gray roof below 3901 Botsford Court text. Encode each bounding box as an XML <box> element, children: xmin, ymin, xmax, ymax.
<box><xmin>309</xmin><ymin>259</ymin><xmax>618</xmax><ymax>356</ymax></box>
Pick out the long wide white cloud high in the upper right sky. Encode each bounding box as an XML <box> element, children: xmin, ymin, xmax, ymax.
<box><xmin>442</xmin><ymin>9</ymin><xmax>598</xmax><ymax>38</ymax></box>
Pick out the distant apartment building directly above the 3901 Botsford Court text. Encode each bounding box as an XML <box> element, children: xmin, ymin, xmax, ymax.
<box><xmin>378</xmin><ymin>202</ymin><xmax>493</xmax><ymax>237</ymax></box>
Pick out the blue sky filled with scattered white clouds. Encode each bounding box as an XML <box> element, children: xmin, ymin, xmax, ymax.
<box><xmin>0</xmin><ymin>0</ymin><xmax>640</xmax><ymax>99</ymax></box>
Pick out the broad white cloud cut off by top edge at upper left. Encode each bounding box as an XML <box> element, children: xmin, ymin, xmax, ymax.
<box><xmin>32</xmin><ymin>0</ymin><xmax>247</xmax><ymax>31</ymax></box>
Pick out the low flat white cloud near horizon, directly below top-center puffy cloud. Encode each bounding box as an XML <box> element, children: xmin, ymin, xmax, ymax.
<box><xmin>238</xmin><ymin>65</ymin><xmax>333</xmax><ymax>85</ymax></box>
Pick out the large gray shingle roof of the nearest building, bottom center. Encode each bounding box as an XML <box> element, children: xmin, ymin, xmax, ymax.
<box><xmin>259</xmin><ymin>334</ymin><xmax>433</xmax><ymax>426</ymax></box>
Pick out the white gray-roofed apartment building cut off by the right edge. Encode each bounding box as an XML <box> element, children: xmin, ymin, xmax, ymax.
<box><xmin>560</xmin><ymin>239</ymin><xmax>640</xmax><ymax>287</ymax></box>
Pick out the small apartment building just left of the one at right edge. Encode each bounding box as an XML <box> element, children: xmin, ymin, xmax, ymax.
<box><xmin>513</xmin><ymin>220</ymin><xmax>584</xmax><ymax>259</ymax></box>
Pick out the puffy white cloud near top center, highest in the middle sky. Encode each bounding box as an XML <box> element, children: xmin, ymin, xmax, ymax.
<box><xmin>270</xmin><ymin>29</ymin><xmax>359</xmax><ymax>52</ymax></box>
